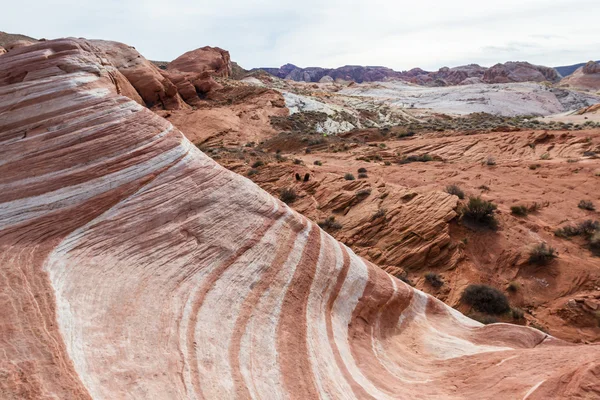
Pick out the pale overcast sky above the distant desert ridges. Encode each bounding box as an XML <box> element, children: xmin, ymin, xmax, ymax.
<box><xmin>0</xmin><ymin>0</ymin><xmax>600</xmax><ymax>70</ymax></box>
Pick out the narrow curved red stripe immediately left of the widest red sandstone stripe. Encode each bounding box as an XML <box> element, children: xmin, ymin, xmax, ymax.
<box><xmin>229</xmin><ymin>214</ymin><xmax>306</xmax><ymax>399</ymax></box>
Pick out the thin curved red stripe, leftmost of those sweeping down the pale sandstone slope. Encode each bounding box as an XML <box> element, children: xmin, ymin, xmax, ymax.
<box><xmin>186</xmin><ymin>209</ymin><xmax>284</xmax><ymax>399</ymax></box>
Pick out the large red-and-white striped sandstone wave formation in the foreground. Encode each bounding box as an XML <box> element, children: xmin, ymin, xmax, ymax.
<box><xmin>0</xmin><ymin>39</ymin><xmax>600</xmax><ymax>399</ymax></box>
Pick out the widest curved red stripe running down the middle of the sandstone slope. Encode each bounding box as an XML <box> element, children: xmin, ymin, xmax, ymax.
<box><xmin>277</xmin><ymin>224</ymin><xmax>321</xmax><ymax>400</ymax></box>
